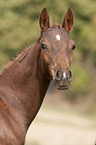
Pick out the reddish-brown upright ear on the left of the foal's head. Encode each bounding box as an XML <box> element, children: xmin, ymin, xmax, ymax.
<box><xmin>39</xmin><ymin>8</ymin><xmax>49</xmax><ymax>31</ymax></box>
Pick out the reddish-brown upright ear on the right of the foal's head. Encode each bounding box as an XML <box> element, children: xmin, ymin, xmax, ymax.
<box><xmin>62</xmin><ymin>8</ymin><xmax>74</xmax><ymax>33</ymax></box>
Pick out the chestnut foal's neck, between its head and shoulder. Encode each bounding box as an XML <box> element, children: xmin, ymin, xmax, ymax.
<box><xmin>0</xmin><ymin>38</ymin><xmax>50</xmax><ymax>127</ymax></box>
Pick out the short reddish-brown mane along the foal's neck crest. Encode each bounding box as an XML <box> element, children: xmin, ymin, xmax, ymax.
<box><xmin>0</xmin><ymin>46</ymin><xmax>31</xmax><ymax>76</ymax></box>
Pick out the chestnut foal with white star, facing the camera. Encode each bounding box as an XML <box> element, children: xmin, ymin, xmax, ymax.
<box><xmin>0</xmin><ymin>8</ymin><xmax>75</xmax><ymax>145</ymax></box>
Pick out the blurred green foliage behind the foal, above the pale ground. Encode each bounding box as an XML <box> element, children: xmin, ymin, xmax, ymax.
<box><xmin>0</xmin><ymin>0</ymin><xmax>96</xmax><ymax>113</ymax></box>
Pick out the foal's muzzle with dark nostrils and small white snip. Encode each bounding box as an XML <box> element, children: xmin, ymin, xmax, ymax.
<box><xmin>53</xmin><ymin>70</ymin><xmax>73</xmax><ymax>90</ymax></box>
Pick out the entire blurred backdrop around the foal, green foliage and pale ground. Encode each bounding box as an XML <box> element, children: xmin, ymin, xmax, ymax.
<box><xmin>0</xmin><ymin>0</ymin><xmax>96</xmax><ymax>145</ymax></box>
